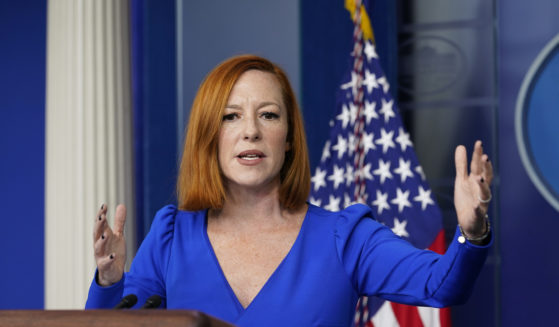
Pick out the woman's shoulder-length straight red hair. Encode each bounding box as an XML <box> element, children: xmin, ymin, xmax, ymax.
<box><xmin>177</xmin><ymin>55</ymin><xmax>310</xmax><ymax>211</ymax></box>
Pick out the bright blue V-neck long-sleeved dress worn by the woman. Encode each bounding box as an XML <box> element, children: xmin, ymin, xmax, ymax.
<box><xmin>86</xmin><ymin>205</ymin><xmax>489</xmax><ymax>326</ymax></box>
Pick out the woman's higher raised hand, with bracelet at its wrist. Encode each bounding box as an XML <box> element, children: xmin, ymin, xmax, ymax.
<box><xmin>454</xmin><ymin>141</ymin><xmax>493</xmax><ymax>238</ymax></box>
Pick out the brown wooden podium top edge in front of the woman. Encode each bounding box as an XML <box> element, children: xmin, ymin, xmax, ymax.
<box><xmin>0</xmin><ymin>309</ymin><xmax>234</xmax><ymax>327</ymax></box>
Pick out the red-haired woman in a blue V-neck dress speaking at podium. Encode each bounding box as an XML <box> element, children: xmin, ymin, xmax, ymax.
<box><xmin>86</xmin><ymin>56</ymin><xmax>492</xmax><ymax>326</ymax></box>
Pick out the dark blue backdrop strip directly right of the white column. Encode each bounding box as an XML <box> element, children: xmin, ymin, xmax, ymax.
<box><xmin>131</xmin><ymin>0</ymin><xmax>178</xmax><ymax>245</ymax></box>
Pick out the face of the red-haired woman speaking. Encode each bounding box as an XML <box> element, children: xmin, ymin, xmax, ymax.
<box><xmin>218</xmin><ymin>70</ymin><xmax>289</xmax><ymax>189</ymax></box>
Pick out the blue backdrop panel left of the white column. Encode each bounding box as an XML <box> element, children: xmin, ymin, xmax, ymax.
<box><xmin>0</xmin><ymin>0</ymin><xmax>47</xmax><ymax>309</ymax></box>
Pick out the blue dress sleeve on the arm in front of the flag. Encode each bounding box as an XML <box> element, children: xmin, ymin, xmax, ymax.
<box><xmin>335</xmin><ymin>205</ymin><xmax>489</xmax><ymax>307</ymax></box>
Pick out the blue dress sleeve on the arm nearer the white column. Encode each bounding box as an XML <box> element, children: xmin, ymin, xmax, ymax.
<box><xmin>86</xmin><ymin>205</ymin><xmax>177</xmax><ymax>308</ymax></box>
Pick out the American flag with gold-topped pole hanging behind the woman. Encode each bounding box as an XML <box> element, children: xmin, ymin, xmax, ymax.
<box><xmin>310</xmin><ymin>0</ymin><xmax>449</xmax><ymax>326</ymax></box>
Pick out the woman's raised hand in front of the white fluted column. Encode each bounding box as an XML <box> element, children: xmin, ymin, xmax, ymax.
<box><xmin>93</xmin><ymin>204</ymin><xmax>126</xmax><ymax>286</ymax></box>
